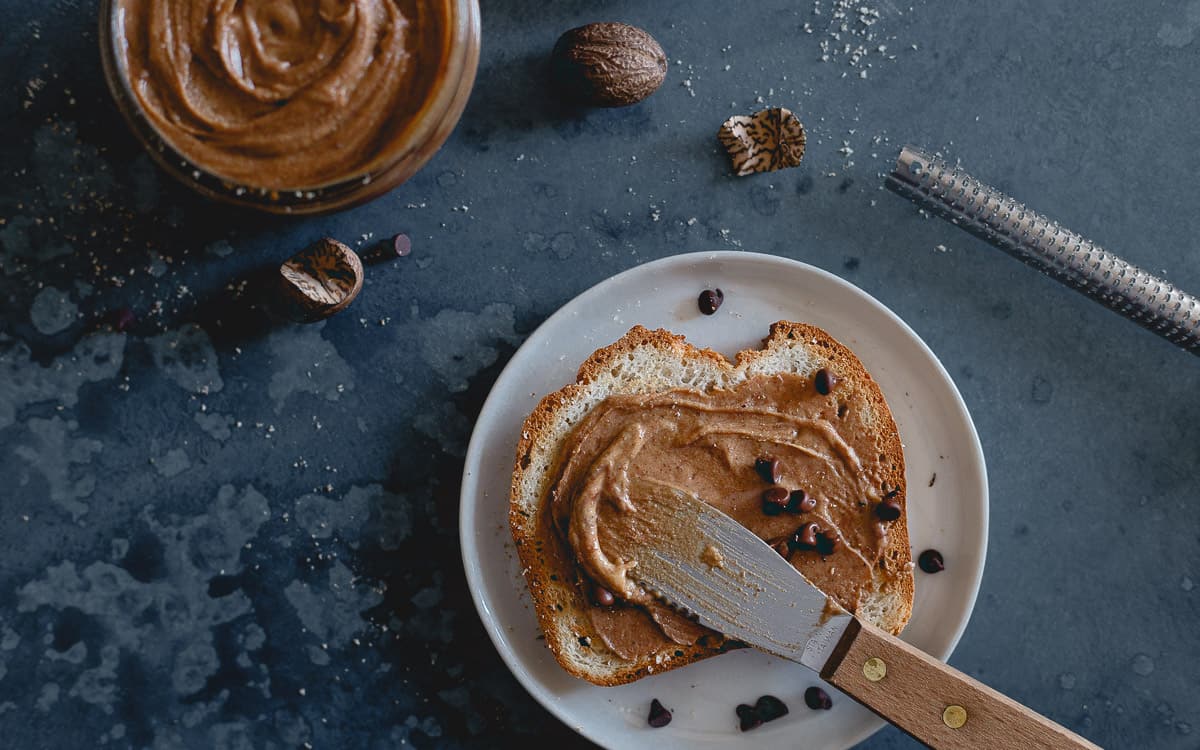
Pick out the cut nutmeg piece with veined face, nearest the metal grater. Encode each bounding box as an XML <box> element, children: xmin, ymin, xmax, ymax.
<box><xmin>716</xmin><ymin>107</ymin><xmax>806</xmax><ymax>176</ymax></box>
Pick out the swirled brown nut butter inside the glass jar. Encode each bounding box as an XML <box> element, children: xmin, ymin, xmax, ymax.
<box><xmin>114</xmin><ymin>0</ymin><xmax>449</xmax><ymax>190</ymax></box>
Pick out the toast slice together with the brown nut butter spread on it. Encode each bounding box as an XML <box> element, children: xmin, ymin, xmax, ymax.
<box><xmin>510</xmin><ymin>323</ymin><xmax>912</xmax><ymax>684</ymax></box>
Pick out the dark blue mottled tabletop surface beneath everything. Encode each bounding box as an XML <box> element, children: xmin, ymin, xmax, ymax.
<box><xmin>0</xmin><ymin>0</ymin><xmax>1200</xmax><ymax>748</ymax></box>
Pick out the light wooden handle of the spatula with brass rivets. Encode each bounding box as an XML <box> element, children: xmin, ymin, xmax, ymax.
<box><xmin>821</xmin><ymin>619</ymin><xmax>1097</xmax><ymax>750</ymax></box>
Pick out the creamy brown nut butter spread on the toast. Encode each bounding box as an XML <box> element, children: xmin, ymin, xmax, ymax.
<box><xmin>550</xmin><ymin>374</ymin><xmax>887</xmax><ymax>660</ymax></box>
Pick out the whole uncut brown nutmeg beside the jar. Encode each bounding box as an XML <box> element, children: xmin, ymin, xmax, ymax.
<box><xmin>551</xmin><ymin>23</ymin><xmax>667</xmax><ymax>107</ymax></box>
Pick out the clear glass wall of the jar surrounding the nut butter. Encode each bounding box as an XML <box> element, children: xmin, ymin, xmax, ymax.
<box><xmin>100</xmin><ymin>0</ymin><xmax>480</xmax><ymax>215</ymax></box>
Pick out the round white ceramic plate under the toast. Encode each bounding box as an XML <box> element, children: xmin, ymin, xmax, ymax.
<box><xmin>460</xmin><ymin>252</ymin><xmax>988</xmax><ymax>750</ymax></box>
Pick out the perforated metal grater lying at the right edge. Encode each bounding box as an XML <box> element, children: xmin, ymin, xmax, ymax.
<box><xmin>887</xmin><ymin>145</ymin><xmax>1200</xmax><ymax>355</ymax></box>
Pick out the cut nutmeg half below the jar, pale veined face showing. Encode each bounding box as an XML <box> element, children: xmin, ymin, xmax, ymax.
<box><xmin>271</xmin><ymin>238</ymin><xmax>362</xmax><ymax>323</ymax></box>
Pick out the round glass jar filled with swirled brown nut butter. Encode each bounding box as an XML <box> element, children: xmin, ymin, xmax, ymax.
<box><xmin>100</xmin><ymin>0</ymin><xmax>480</xmax><ymax>214</ymax></box>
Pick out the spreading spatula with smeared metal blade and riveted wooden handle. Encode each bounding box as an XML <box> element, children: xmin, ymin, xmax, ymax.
<box><xmin>605</xmin><ymin>480</ymin><xmax>1097</xmax><ymax>750</ymax></box>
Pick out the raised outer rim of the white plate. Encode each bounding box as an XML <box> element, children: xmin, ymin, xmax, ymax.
<box><xmin>458</xmin><ymin>250</ymin><xmax>991</xmax><ymax>748</ymax></box>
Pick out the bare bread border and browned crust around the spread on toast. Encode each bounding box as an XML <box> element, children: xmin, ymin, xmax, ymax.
<box><xmin>509</xmin><ymin>322</ymin><xmax>913</xmax><ymax>685</ymax></box>
